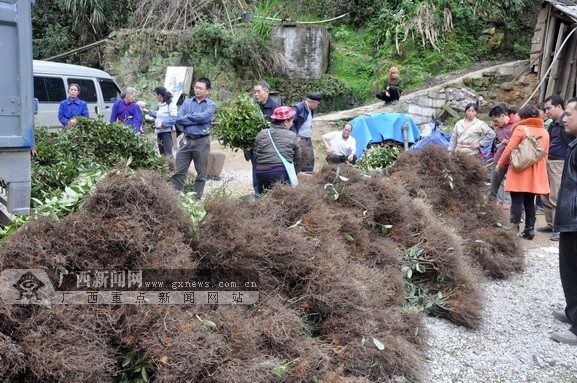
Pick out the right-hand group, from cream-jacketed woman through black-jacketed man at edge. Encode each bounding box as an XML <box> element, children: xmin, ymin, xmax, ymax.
<box><xmin>449</xmin><ymin>95</ymin><xmax>577</xmax><ymax>345</ymax></box>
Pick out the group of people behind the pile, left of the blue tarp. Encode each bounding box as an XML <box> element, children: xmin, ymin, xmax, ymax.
<box><xmin>58</xmin><ymin>78</ymin><xmax>356</xmax><ymax>199</ymax></box>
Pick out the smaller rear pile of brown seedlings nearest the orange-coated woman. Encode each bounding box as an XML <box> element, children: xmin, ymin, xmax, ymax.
<box><xmin>387</xmin><ymin>145</ymin><xmax>523</xmax><ymax>278</ymax></box>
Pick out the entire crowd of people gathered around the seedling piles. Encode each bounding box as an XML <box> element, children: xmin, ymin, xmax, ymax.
<box><xmin>51</xmin><ymin>67</ymin><xmax>577</xmax><ymax>345</ymax></box>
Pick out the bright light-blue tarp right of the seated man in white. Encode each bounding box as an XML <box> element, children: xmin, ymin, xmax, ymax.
<box><xmin>350</xmin><ymin>113</ymin><xmax>420</xmax><ymax>157</ymax></box>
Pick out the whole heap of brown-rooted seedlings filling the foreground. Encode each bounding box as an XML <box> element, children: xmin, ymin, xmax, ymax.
<box><xmin>0</xmin><ymin>143</ymin><xmax>522</xmax><ymax>383</ymax></box>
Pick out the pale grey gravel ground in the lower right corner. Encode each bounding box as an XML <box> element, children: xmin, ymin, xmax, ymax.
<box><xmin>425</xmin><ymin>242</ymin><xmax>577</xmax><ymax>383</ymax></box>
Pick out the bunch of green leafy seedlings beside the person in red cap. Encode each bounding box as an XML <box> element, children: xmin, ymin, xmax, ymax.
<box><xmin>212</xmin><ymin>94</ymin><xmax>268</xmax><ymax>150</ymax></box>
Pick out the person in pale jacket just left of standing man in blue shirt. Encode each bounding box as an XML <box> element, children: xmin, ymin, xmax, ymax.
<box><xmin>141</xmin><ymin>86</ymin><xmax>177</xmax><ymax>158</ymax></box>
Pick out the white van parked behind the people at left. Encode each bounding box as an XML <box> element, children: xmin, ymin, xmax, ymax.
<box><xmin>33</xmin><ymin>60</ymin><xmax>120</xmax><ymax>130</ymax></box>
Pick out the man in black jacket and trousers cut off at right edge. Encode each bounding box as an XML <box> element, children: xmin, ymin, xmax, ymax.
<box><xmin>551</xmin><ymin>97</ymin><xmax>577</xmax><ymax>346</ymax></box>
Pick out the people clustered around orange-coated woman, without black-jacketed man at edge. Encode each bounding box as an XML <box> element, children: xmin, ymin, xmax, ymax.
<box><xmin>448</xmin><ymin>95</ymin><xmax>572</xmax><ymax>241</ymax></box>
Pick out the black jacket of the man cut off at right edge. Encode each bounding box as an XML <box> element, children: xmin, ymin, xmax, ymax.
<box><xmin>554</xmin><ymin>138</ymin><xmax>577</xmax><ymax>233</ymax></box>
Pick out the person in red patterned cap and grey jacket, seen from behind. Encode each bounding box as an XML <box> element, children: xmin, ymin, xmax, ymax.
<box><xmin>254</xmin><ymin>106</ymin><xmax>301</xmax><ymax>194</ymax></box>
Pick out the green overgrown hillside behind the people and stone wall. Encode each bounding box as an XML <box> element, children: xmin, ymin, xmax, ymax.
<box><xmin>33</xmin><ymin>0</ymin><xmax>539</xmax><ymax>103</ymax></box>
